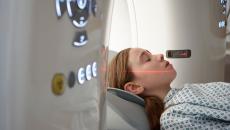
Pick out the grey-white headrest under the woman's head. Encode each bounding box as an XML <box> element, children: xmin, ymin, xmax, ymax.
<box><xmin>106</xmin><ymin>88</ymin><xmax>149</xmax><ymax>130</ymax></box>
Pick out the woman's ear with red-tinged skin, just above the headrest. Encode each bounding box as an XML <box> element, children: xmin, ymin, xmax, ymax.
<box><xmin>124</xmin><ymin>82</ymin><xmax>144</xmax><ymax>95</ymax></box>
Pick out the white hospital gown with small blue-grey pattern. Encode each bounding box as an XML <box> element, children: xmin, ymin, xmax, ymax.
<box><xmin>160</xmin><ymin>82</ymin><xmax>230</xmax><ymax>130</ymax></box>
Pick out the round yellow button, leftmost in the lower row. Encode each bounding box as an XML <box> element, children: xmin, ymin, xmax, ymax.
<box><xmin>52</xmin><ymin>73</ymin><xmax>65</xmax><ymax>95</ymax></box>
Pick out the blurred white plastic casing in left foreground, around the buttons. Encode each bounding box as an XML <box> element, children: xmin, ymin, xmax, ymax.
<box><xmin>0</xmin><ymin>0</ymin><xmax>113</xmax><ymax>130</ymax></box>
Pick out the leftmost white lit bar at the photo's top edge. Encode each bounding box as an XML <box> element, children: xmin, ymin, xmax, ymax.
<box><xmin>55</xmin><ymin>0</ymin><xmax>66</xmax><ymax>18</ymax></box>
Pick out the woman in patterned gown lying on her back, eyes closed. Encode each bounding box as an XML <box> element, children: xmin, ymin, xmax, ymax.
<box><xmin>109</xmin><ymin>48</ymin><xmax>230</xmax><ymax>130</ymax></box>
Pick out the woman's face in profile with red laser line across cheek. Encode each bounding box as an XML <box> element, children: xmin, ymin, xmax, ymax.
<box><xmin>128</xmin><ymin>48</ymin><xmax>176</xmax><ymax>92</ymax></box>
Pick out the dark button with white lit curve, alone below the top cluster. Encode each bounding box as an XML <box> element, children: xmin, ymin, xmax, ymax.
<box><xmin>73</xmin><ymin>31</ymin><xmax>88</xmax><ymax>47</ymax></box>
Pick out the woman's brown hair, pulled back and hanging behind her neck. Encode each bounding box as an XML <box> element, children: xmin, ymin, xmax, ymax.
<box><xmin>108</xmin><ymin>48</ymin><xmax>164</xmax><ymax>130</ymax></box>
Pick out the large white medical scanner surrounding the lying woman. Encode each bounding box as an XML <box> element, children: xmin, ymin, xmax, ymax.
<box><xmin>0</xmin><ymin>0</ymin><xmax>230</xmax><ymax>130</ymax></box>
